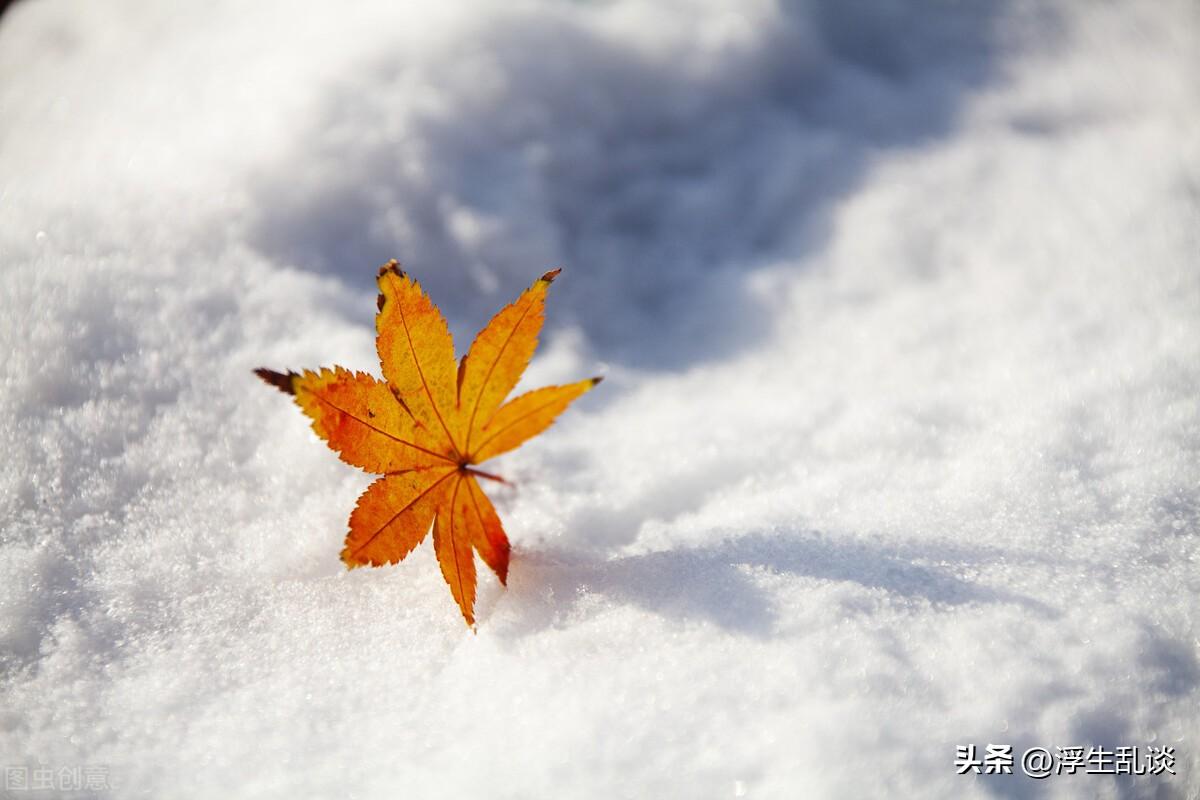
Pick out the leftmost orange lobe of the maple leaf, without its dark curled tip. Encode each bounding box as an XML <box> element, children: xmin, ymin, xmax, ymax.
<box><xmin>290</xmin><ymin>367</ymin><xmax>446</xmax><ymax>473</ymax></box>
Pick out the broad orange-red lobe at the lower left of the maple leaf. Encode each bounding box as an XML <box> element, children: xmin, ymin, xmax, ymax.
<box><xmin>342</xmin><ymin>468</ymin><xmax>458</xmax><ymax>569</ymax></box>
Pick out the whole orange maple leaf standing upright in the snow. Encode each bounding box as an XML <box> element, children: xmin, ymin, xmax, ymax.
<box><xmin>254</xmin><ymin>260</ymin><xmax>600</xmax><ymax>625</ymax></box>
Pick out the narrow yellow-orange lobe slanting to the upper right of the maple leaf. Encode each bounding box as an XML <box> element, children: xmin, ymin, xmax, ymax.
<box><xmin>457</xmin><ymin>270</ymin><xmax>559</xmax><ymax>453</ymax></box>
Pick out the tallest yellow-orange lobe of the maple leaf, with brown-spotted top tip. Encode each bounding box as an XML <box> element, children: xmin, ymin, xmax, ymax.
<box><xmin>376</xmin><ymin>261</ymin><xmax>462</xmax><ymax>462</ymax></box>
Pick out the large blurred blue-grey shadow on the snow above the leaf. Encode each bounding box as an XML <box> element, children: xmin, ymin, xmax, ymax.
<box><xmin>243</xmin><ymin>0</ymin><xmax>1041</xmax><ymax>369</ymax></box>
